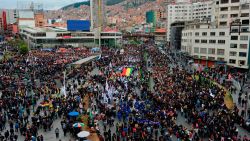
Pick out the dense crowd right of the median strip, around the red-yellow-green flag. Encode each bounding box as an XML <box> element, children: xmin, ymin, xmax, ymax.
<box><xmin>85</xmin><ymin>45</ymin><xmax>248</xmax><ymax>141</ymax></box>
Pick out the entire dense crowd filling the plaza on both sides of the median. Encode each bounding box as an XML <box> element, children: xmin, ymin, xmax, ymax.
<box><xmin>0</xmin><ymin>43</ymin><xmax>249</xmax><ymax>141</ymax></box>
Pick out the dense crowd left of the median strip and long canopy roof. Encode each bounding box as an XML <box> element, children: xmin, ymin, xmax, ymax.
<box><xmin>0</xmin><ymin>48</ymin><xmax>93</xmax><ymax>141</ymax></box>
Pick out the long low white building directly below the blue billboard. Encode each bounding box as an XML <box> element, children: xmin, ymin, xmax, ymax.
<box><xmin>20</xmin><ymin>27</ymin><xmax>122</xmax><ymax>48</ymax></box>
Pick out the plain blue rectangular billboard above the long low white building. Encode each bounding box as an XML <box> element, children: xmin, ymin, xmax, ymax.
<box><xmin>67</xmin><ymin>20</ymin><xmax>90</xmax><ymax>31</ymax></box>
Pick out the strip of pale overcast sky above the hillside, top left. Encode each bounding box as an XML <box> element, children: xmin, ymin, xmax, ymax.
<box><xmin>0</xmin><ymin>0</ymin><xmax>87</xmax><ymax>10</ymax></box>
